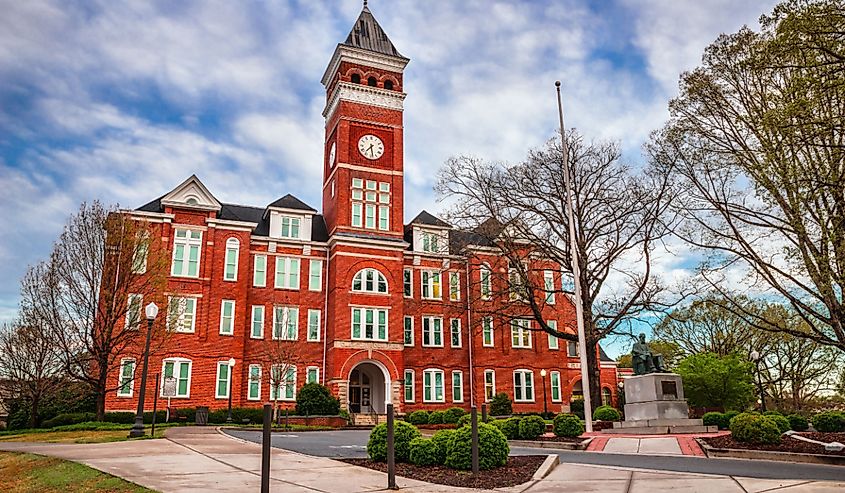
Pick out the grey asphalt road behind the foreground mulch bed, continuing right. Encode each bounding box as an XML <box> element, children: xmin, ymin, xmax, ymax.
<box><xmin>225</xmin><ymin>430</ymin><xmax>845</xmax><ymax>481</ymax></box>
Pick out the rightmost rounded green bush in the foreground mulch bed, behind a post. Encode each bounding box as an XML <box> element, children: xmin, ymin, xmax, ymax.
<box><xmin>445</xmin><ymin>423</ymin><xmax>510</xmax><ymax>470</ymax></box>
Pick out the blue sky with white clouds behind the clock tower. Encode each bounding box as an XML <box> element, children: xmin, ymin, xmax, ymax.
<box><xmin>0</xmin><ymin>0</ymin><xmax>775</xmax><ymax>356</ymax></box>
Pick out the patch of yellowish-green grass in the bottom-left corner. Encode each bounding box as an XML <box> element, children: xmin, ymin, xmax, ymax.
<box><xmin>0</xmin><ymin>452</ymin><xmax>155</xmax><ymax>493</ymax></box>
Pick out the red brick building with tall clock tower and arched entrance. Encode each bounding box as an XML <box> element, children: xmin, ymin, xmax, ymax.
<box><xmin>106</xmin><ymin>3</ymin><xmax>616</xmax><ymax>413</ymax></box>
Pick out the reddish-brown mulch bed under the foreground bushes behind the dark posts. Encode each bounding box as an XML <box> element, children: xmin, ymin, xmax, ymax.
<box><xmin>341</xmin><ymin>455</ymin><xmax>546</xmax><ymax>489</ymax></box>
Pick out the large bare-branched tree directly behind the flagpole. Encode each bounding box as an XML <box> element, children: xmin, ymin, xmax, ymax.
<box><xmin>436</xmin><ymin>131</ymin><xmax>673</xmax><ymax>402</ymax></box>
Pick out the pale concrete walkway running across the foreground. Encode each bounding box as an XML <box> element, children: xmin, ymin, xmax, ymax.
<box><xmin>0</xmin><ymin>427</ymin><xmax>845</xmax><ymax>493</ymax></box>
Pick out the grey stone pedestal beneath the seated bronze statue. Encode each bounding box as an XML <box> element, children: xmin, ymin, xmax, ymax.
<box><xmin>604</xmin><ymin>373</ymin><xmax>717</xmax><ymax>435</ymax></box>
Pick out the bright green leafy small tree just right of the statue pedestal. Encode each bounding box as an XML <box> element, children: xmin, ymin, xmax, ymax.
<box><xmin>676</xmin><ymin>353</ymin><xmax>754</xmax><ymax>410</ymax></box>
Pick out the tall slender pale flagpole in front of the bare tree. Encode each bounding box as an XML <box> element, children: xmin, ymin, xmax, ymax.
<box><xmin>555</xmin><ymin>80</ymin><xmax>595</xmax><ymax>432</ymax></box>
